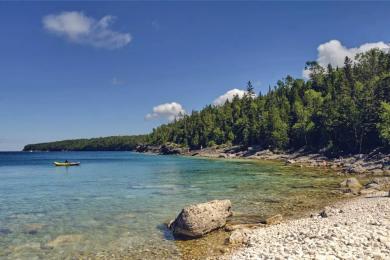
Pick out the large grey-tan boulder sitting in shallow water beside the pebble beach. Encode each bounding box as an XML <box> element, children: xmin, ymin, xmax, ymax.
<box><xmin>169</xmin><ymin>200</ymin><xmax>232</xmax><ymax>239</ymax></box>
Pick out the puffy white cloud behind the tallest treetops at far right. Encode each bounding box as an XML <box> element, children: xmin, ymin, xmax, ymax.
<box><xmin>302</xmin><ymin>40</ymin><xmax>390</xmax><ymax>78</ymax></box>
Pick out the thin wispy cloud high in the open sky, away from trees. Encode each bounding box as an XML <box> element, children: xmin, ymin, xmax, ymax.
<box><xmin>42</xmin><ymin>11</ymin><xmax>132</xmax><ymax>49</ymax></box>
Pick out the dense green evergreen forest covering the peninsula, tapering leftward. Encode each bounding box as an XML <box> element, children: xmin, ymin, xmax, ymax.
<box><xmin>24</xmin><ymin>49</ymin><xmax>390</xmax><ymax>156</ymax></box>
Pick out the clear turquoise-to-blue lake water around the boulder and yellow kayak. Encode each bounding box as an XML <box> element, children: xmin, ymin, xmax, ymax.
<box><xmin>0</xmin><ymin>152</ymin><xmax>340</xmax><ymax>259</ymax></box>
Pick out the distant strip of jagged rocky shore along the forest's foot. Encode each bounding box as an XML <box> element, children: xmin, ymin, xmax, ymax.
<box><xmin>135</xmin><ymin>145</ymin><xmax>390</xmax><ymax>176</ymax></box>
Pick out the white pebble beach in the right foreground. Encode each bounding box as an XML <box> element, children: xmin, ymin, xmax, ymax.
<box><xmin>224</xmin><ymin>192</ymin><xmax>390</xmax><ymax>259</ymax></box>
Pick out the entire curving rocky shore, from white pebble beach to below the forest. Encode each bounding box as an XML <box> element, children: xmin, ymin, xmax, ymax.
<box><xmin>135</xmin><ymin>146</ymin><xmax>390</xmax><ymax>259</ymax></box>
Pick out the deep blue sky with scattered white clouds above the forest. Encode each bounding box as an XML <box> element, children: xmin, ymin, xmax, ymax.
<box><xmin>0</xmin><ymin>1</ymin><xmax>390</xmax><ymax>151</ymax></box>
